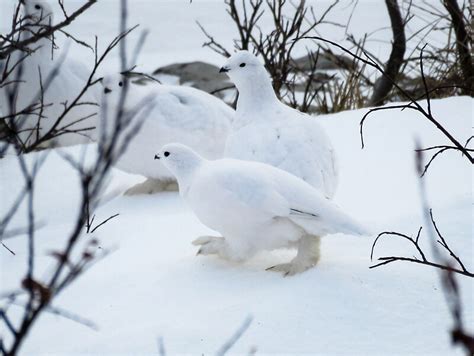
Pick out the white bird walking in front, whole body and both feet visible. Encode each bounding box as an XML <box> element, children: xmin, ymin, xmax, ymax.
<box><xmin>155</xmin><ymin>143</ymin><xmax>365</xmax><ymax>275</ymax></box>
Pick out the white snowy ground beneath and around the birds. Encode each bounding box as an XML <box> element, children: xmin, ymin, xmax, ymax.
<box><xmin>0</xmin><ymin>97</ymin><xmax>474</xmax><ymax>355</ymax></box>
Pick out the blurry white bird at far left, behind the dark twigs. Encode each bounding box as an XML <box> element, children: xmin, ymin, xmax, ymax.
<box><xmin>0</xmin><ymin>0</ymin><xmax>101</xmax><ymax>146</ymax></box>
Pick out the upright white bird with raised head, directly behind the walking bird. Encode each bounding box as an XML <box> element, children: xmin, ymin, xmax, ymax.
<box><xmin>220</xmin><ymin>51</ymin><xmax>338</xmax><ymax>198</ymax></box>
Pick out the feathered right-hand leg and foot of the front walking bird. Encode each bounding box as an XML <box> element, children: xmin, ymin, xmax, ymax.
<box><xmin>267</xmin><ymin>235</ymin><xmax>321</xmax><ymax>277</ymax></box>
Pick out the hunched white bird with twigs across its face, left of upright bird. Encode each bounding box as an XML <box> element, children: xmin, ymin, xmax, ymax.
<box><xmin>102</xmin><ymin>75</ymin><xmax>235</xmax><ymax>195</ymax></box>
